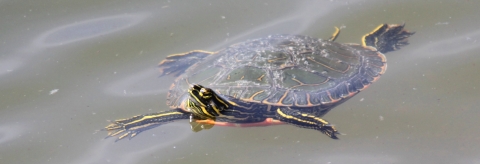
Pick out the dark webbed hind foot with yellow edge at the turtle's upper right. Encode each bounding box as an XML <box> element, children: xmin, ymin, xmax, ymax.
<box><xmin>362</xmin><ymin>24</ymin><xmax>415</xmax><ymax>53</ymax></box>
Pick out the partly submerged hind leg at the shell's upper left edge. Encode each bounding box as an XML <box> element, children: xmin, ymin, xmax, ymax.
<box><xmin>158</xmin><ymin>50</ymin><xmax>214</xmax><ymax>76</ymax></box>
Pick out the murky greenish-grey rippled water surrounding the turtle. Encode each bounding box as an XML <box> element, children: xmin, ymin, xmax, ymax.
<box><xmin>0</xmin><ymin>0</ymin><xmax>480</xmax><ymax>164</ymax></box>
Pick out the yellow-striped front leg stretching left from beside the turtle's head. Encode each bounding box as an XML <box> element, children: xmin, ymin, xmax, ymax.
<box><xmin>103</xmin><ymin>110</ymin><xmax>190</xmax><ymax>142</ymax></box>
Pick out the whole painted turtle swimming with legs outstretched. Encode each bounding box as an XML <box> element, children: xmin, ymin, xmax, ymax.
<box><xmin>104</xmin><ymin>24</ymin><xmax>414</xmax><ymax>141</ymax></box>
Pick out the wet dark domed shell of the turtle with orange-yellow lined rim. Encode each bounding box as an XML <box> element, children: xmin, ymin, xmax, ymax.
<box><xmin>167</xmin><ymin>35</ymin><xmax>386</xmax><ymax>109</ymax></box>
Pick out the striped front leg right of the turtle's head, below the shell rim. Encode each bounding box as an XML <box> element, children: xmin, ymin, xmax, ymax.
<box><xmin>276</xmin><ymin>108</ymin><xmax>340</xmax><ymax>139</ymax></box>
